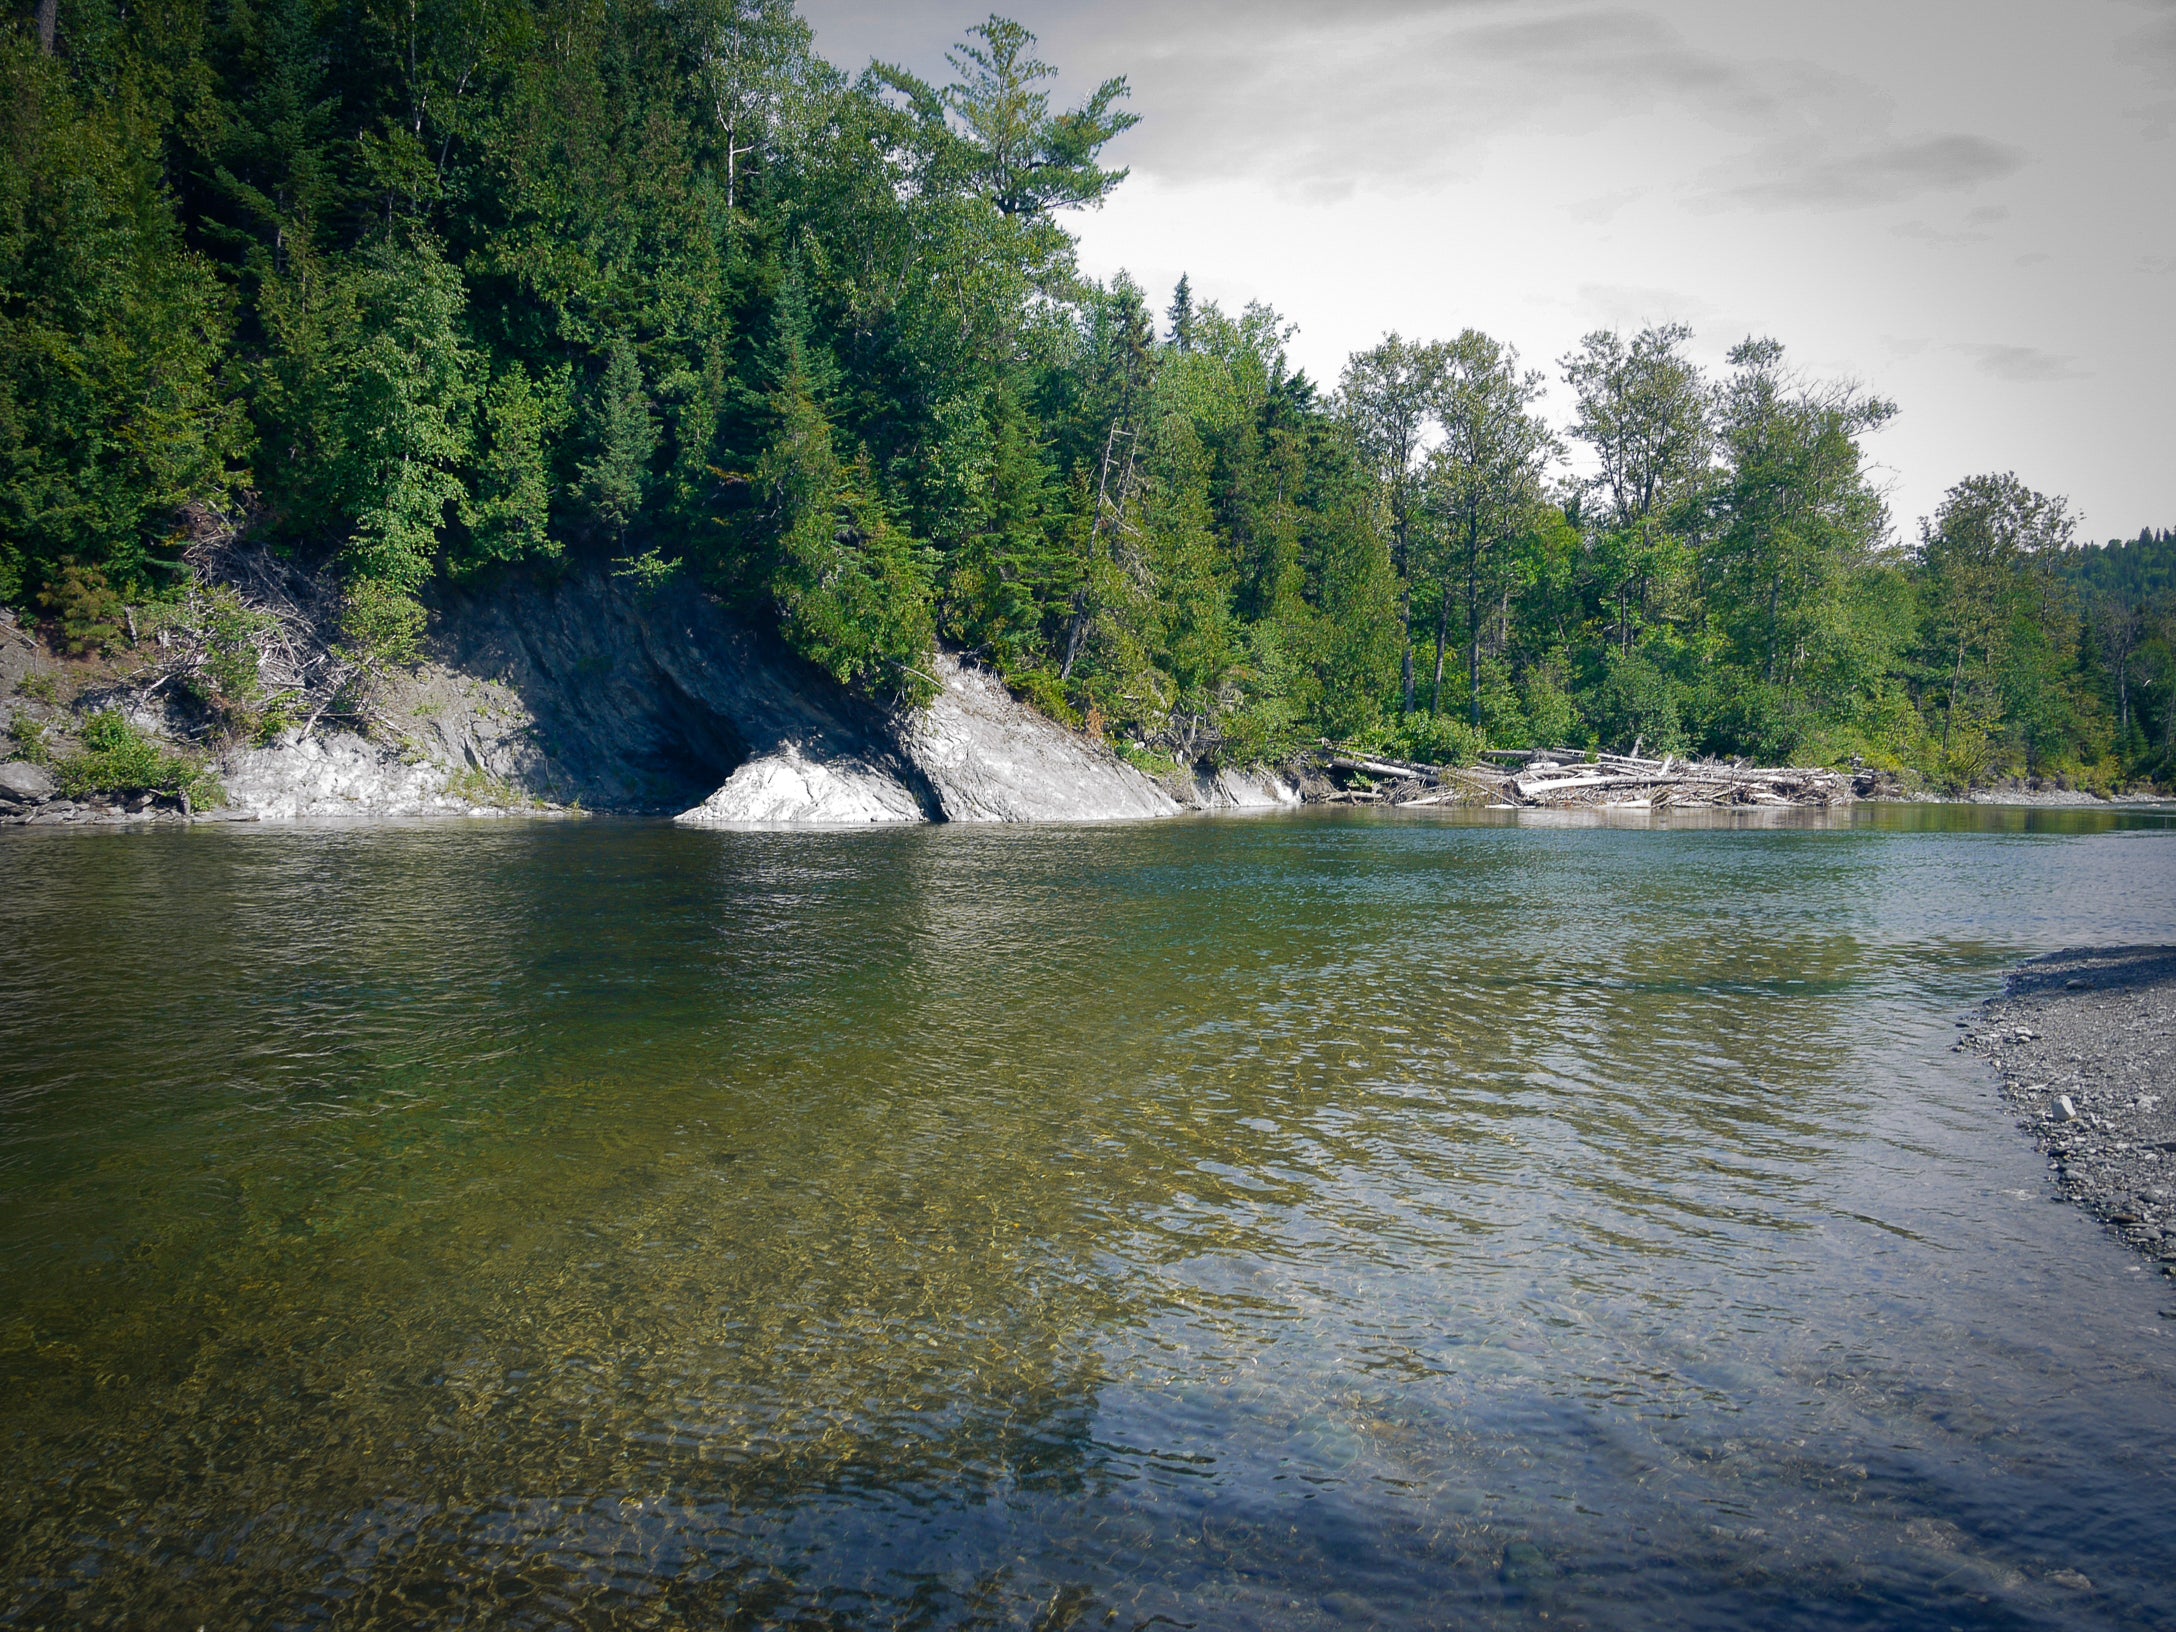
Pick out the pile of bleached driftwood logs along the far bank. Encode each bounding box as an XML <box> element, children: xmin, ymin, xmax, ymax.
<box><xmin>1316</xmin><ymin>744</ymin><xmax>1856</xmax><ymax>809</ymax></box>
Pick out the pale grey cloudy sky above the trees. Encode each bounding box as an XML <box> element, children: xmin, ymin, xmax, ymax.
<box><xmin>803</xmin><ymin>0</ymin><xmax>2176</xmax><ymax>550</ymax></box>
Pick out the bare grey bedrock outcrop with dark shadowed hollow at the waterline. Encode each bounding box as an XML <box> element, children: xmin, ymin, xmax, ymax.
<box><xmin>207</xmin><ymin>570</ymin><xmax>1270</xmax><ymax>827</ymax></box>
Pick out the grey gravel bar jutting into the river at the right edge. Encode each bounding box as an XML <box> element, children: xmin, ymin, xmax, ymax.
<box><xmin>1956</xmin><ymin>947</ymin><xmax>2176</xmax><ymax>1275</ymax></box>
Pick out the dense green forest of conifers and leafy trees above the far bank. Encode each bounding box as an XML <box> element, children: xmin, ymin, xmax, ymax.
<box><xmin>0</xmin><ymin>0</ymin><xmax>2176</xmax><ymax>781</ymax></box>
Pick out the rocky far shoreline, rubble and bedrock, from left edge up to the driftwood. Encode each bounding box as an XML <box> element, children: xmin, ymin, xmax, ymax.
<box><xmin>0</xmin><ymin>570</ymin><xmax>1301</xmax><ymax>827</ymax></box>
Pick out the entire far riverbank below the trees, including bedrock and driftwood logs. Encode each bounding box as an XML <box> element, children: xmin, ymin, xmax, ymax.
<box><xmin>0</xmin><ymin>570</ymin><xmax>2150</xmax><ymax>827</ymax></box>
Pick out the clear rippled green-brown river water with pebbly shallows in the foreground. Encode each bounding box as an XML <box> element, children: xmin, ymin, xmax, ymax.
<box><xmin>0</xmin><ymin>809</ymin><xmax>2176</xmax><ymax>1628</ymax></box>
